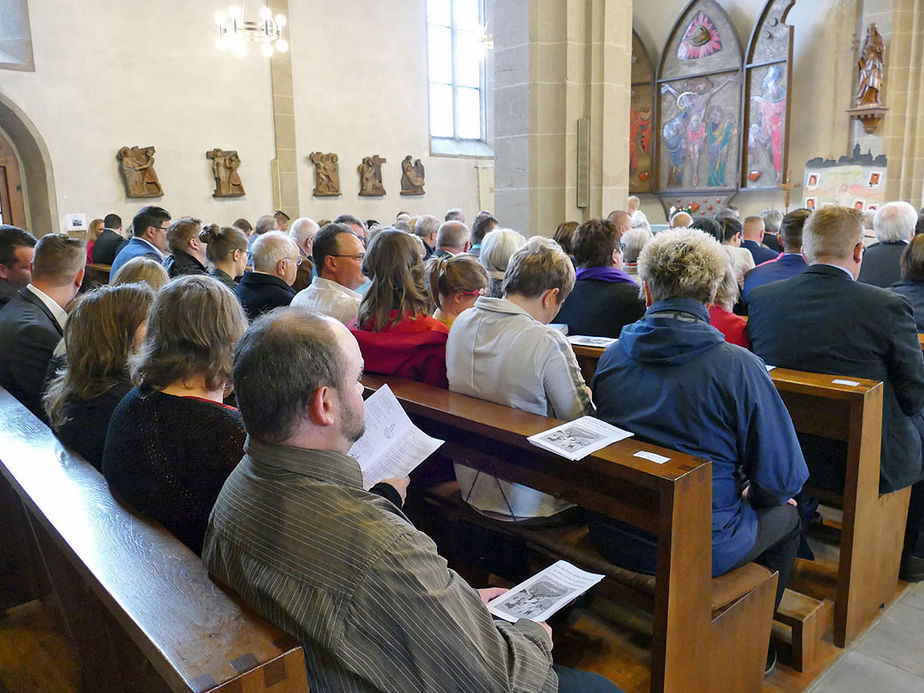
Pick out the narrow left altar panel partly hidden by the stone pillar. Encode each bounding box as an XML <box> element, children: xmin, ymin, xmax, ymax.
<box><xmin>629</xmin><ymin>31</ymin><xmax>654</xmax><ymax>194</ymax></box>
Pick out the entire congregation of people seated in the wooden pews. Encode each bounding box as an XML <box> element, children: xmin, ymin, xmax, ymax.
<box><xmin>0</xmin><ymin>200</ymin><xmax>924</xmax><ymax>693</ymax></box>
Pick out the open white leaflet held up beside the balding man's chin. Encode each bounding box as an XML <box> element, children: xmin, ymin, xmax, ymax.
<box><xmin>348</xmin><ymin>385</ymin><xmax>444</xmax><ymax>491</ymax></box>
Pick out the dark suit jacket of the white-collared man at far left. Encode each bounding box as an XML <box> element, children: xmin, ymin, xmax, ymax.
<box><xmin>0</xmin><ymin>289</ymin><xmax>63</xmax><ymax>421</ymax></box>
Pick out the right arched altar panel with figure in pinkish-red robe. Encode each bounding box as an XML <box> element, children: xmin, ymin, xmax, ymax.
<box><xmin>741</xmin><ymin>0</ymin><xmax>795</xmax><ymax>190</ymax></box>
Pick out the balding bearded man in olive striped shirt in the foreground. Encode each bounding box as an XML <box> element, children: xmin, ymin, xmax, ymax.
<box><xmin>202</xmin><ymin>308</ymin><xmax>618</xmax><ymax>693</ymax></box>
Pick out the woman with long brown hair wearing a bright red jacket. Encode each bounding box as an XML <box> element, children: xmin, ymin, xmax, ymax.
<box><xmin>347</xmin><ymin>229</ymin><xmax>449</xmax><ymax>388</ymax></box>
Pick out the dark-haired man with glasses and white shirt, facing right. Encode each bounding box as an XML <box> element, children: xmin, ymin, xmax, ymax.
<box><xmin>292</xmin><ymin>222</ymin><xmax>366</xmax><ymax>324</ymax></box>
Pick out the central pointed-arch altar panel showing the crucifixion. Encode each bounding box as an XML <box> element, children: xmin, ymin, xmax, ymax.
<box><xmin>656</xmin><ymin>0</ymin><xmax>742</xmax><ymax>195</ymax></box>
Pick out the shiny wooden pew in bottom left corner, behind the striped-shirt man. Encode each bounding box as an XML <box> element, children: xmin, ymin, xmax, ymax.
<box><xmin>0</xmin><ymin>388</ymin><xmax>308</xmax><ymax>693</ymax></box>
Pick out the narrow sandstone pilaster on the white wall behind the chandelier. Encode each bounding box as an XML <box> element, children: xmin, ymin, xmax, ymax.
<box><xmin>270</xmin><ymin>0</ymin><xmax>299</xmax><ymax>220</ymax></box>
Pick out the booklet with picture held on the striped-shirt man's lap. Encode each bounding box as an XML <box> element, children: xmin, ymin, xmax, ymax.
<box><xmin>488</xmin><ymin>561</ymin><xmax>604</xmax><ymax>622</ymax></box>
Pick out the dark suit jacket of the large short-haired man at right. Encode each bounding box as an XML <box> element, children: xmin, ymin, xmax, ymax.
<box><xmin>747</xmin><ymin>265</ymin><xmax>924</xmax><ymax>493</ymax></box>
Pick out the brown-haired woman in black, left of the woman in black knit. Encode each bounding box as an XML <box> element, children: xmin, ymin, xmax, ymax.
<box><xmin>43</xmin><ymin>284</ymin><xmax>154</xmax><ymax>469</ymax></box>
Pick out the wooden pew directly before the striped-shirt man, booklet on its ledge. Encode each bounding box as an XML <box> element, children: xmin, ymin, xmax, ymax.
<box><xmin>363</xmin><ymin>375</ymin><xmax>776</xmax><ymax>692</ymax></box>
